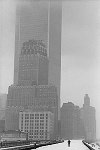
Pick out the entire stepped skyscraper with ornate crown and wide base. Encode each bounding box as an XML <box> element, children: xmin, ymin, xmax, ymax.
<box><xmin>5</xmin><ymin>40</ymin><xmax>58</xmax><ymax>138</ymax></box>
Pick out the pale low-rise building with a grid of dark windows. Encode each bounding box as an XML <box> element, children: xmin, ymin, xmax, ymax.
<box><xmin>19</xmin><ymin>110</ymin><xmax>54</xmax><ymax>140</ymax></box>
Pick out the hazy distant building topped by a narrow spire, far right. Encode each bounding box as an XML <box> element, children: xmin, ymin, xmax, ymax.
<box><xmin>81</xmin><ymin>94</ymin><xmax>96</xmax><ymax>140</ymax></box>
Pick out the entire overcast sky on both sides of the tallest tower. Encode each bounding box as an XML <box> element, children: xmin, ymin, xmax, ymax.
<box><xmin>0</xmin><ymin>0</ymin><xmax>100</xmax><ymax>136</ymax></box>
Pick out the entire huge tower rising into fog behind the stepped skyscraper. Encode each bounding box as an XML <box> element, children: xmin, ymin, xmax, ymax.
<box><xmin>14</xmin><ymin>0</ymin><xmax>62</xmax><ymax>118</ymax></box>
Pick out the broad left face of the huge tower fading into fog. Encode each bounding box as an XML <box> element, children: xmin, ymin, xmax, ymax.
<box><xmin>14</xmin><ymin>0</ymin><xmax>48</xmax><ymax>84</ymax></box>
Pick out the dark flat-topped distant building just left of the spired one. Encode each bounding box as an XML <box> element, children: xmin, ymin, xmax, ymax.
<box><xmin>61</xmin><ymin>102</ymin><xmax>84</xmax><ymax>139</ymax></box>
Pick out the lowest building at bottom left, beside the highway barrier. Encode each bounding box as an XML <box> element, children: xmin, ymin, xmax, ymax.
<box><xmin>1</xmin><ymin>130</ymin><xmax>27</xmax><ymax>141</ymax></box>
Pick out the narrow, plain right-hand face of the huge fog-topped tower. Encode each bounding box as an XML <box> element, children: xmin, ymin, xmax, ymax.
<box><xmin>48</xmin><ymin>0</ymin><xmax>62</xmax><ymax>116</ymax></box>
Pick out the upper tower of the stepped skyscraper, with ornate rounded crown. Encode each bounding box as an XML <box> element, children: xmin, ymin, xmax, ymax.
<box><xmin>17</xmin><ymin>40</ymin><xmax>48</xmax><ymax>86</ymax></box>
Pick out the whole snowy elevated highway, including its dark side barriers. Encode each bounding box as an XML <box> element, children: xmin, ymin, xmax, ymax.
<box><xmin>0</xmin><ymin>140</ymin><xmax>100</xmax><ymax>150</ymax></box>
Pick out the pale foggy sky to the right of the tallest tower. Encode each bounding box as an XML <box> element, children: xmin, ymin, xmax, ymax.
<box><xmin>61</xmin><ymin>1</ymin><xmax>100</xmax><ymax>137</ymax></box>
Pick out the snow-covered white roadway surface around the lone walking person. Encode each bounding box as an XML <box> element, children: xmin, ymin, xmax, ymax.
<box><xmin>37</xmin><ymin>140</ymin><xmax>89</xmax><ymax>150</ymax></box>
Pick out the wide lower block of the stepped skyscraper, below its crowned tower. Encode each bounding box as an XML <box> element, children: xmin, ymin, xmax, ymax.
<box><xmin>5</xmin><ymin>85</ymin><xmax>58</xmax><ymax>136</ymax></box>
